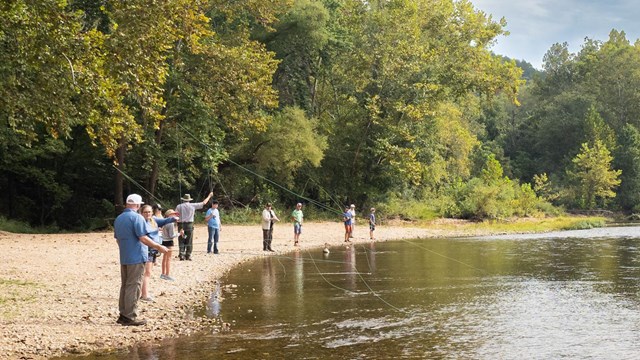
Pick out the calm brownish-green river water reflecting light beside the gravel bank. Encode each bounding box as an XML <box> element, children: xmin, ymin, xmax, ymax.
<box><xmin>69</xmin><ymin>227</ymin><xmax>640</xmax><ymax>359</ymax></box>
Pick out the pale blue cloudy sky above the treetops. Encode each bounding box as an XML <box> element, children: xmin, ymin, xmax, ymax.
<box><xmin>470</xmin><ymin>0</ymin><xmax>640</xmax><ymax>69</ymax></box>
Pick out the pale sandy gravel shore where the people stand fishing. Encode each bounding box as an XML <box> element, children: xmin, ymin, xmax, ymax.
<box><xmin>0</xmin><ymin>222</ymin><xmax>492</xmax><ymax>359</ymax></box>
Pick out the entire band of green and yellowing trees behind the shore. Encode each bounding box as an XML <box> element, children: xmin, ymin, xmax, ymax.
<box><xmin>5</xmin><ymin>0</ymin><xmax>640</xmax><ymax>229</ymax></box>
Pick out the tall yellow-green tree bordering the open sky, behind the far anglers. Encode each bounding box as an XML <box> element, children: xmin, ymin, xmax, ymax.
<box><xmin>318</xmin><ymin>0</ymin><xmax>521</xmax><ymax>202</ymax></box>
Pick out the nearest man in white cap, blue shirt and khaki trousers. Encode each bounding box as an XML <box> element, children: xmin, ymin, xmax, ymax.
<box><xmin>113</xmin><ymin>194</ymin><xmax>167</xmax><ymax>326</ymax></box>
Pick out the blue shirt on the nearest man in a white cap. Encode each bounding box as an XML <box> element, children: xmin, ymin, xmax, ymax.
<box><xmin>113</xmin><ymin>209</ymin><xmax>149</xmax><ymax>265</ymax></box>
